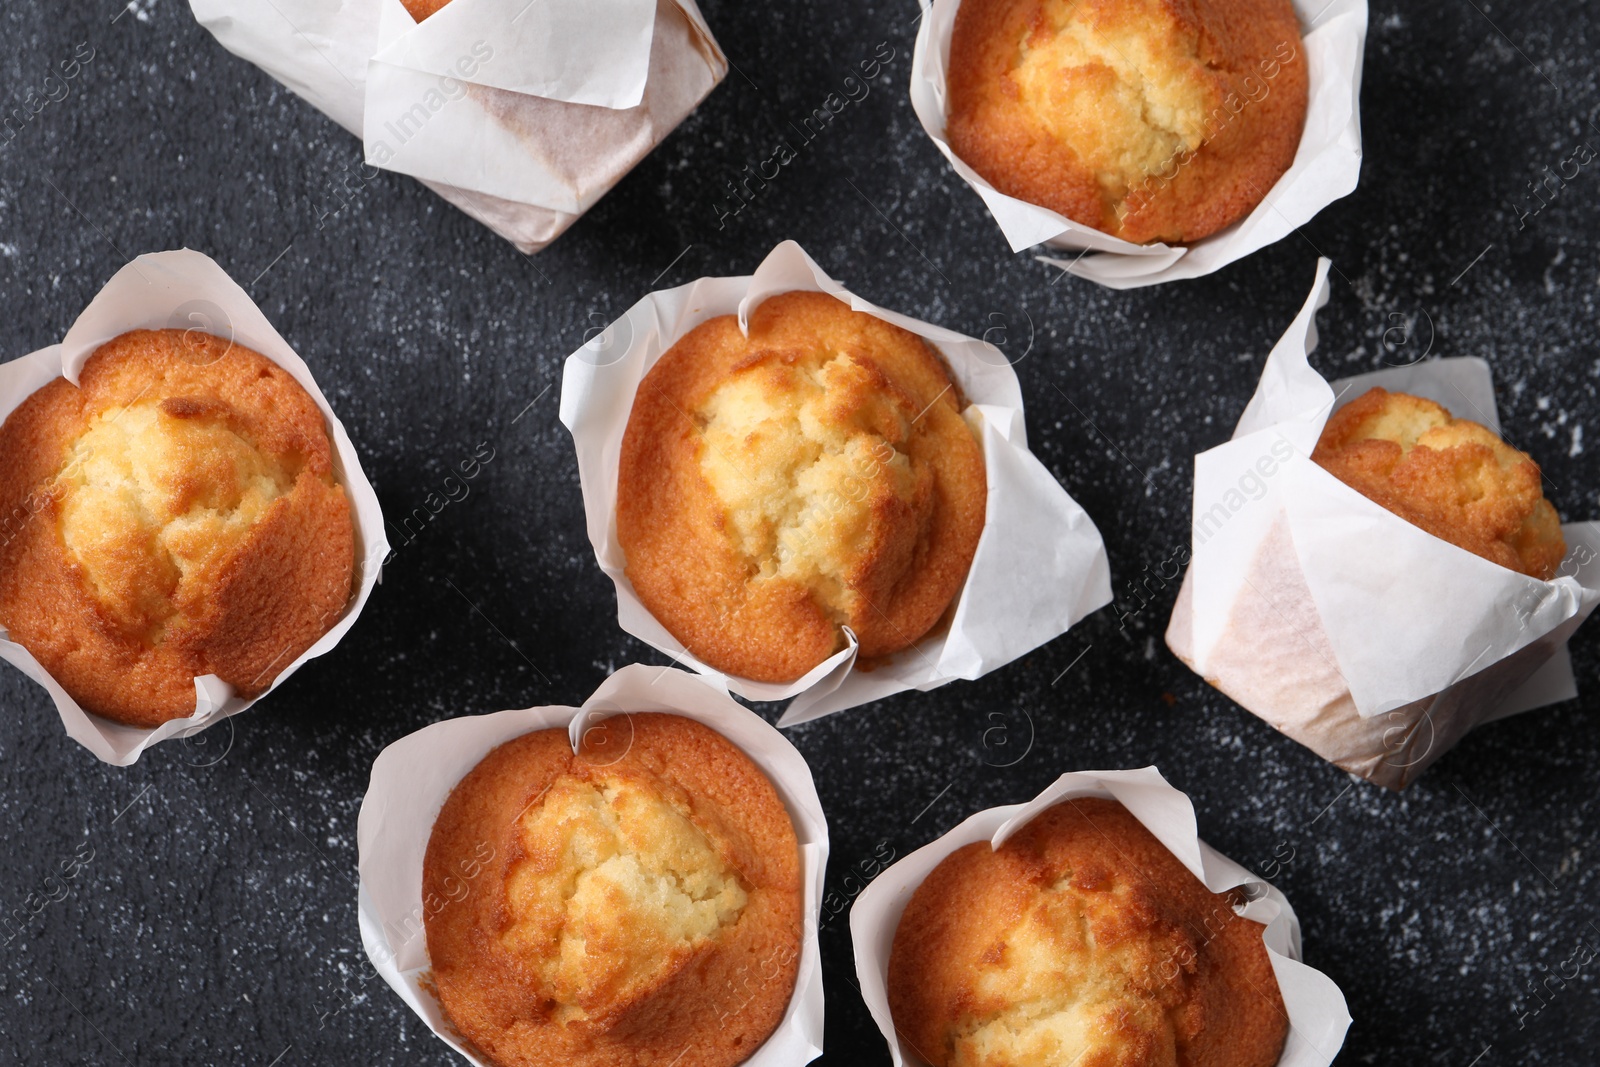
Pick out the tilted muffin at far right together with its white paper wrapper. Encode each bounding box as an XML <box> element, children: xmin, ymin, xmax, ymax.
<box><xmin>1166</xmin><ymin>261</ymin><xmax>1600</xmax><ymax>789</ymax></box>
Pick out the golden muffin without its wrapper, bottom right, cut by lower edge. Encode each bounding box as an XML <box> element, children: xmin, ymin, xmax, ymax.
<box><xmin>888</xmin><ymin>798</ymin><xmax>1288</xmax><ymax>1067</ymax></box>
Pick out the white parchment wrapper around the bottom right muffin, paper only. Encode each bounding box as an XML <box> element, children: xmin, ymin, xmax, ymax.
<box><xmin>850</xmin><ymin>766</ymin><xmax>1350</xmax><ymax>1067</ymax></box>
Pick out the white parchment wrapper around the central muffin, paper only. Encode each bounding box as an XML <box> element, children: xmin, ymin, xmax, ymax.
<box><xmin>562</xmin><ymin>242</ymin><xmax>1110</xmax><ymax>726</ymax></box>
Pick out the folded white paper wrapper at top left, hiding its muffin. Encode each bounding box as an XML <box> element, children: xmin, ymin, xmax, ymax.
<box><xmin>190</xmin><ymin>0</ymin><xmax>728</xmax><ymax>253</ymax></box>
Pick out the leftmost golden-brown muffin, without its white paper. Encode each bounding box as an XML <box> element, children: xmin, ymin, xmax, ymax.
<box><xmin>0</xmin><ymin>330</ymin><xmax>355</xmax><ymax>726</ymax></box>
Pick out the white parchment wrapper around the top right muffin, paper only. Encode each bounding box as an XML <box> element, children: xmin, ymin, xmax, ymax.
<box><xmin>910</xmin><ymin>0</ymin><xmax>1366</xmax><ymax>290</ymax></box>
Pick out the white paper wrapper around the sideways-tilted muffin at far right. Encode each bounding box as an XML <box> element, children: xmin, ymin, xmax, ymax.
<box><xmin>1166</xmin><ymin>261</ymin><xmax>1600</xmax><ymax>789</ymax></box>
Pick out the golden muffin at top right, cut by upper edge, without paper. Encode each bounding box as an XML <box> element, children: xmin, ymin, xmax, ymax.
<box><xmin>946</xmin><ymin>0</ymin><xmax>1309</xmax><ymax>243</ymax></box>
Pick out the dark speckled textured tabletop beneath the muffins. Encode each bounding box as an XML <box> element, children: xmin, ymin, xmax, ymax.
<box><xmin>0</xmin><ymin>0</ymin><xmax>1600</xmax><ymax>1067</ymax></box>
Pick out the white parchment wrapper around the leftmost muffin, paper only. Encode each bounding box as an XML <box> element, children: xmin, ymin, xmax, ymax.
<box><xmin>0</xmin><ymin>248</ymin><xmax>389</xmax><ymax>766</ymax></box>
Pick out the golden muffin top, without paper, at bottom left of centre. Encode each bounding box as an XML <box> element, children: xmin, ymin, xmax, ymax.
<box><xmin>422</xmin><ymin>713</ymin><xmax>802</xmax><ymax>1067</ymax></box>
